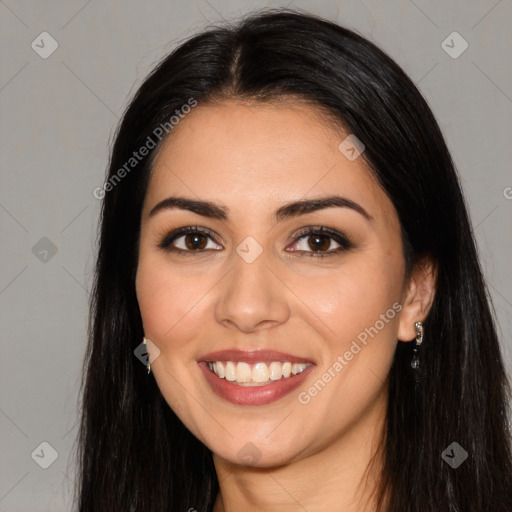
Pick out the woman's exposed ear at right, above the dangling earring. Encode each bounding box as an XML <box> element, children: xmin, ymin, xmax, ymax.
<box><xmin>398</xmin><ymin>257</ymin><xmax>437</xmax><ymax>341</ymax></box>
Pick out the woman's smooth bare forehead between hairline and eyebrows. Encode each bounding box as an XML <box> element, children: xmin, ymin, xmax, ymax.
<box><xmin>146</xmin><ymin>101</ymin><xmax>394</xmax><ymax>225</ymax></box>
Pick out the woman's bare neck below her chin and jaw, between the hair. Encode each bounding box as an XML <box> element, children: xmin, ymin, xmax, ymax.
<box><xmin>213</xmin><ymin>388</ymin><xmax>387</xmax><ymax>512</ymax></box>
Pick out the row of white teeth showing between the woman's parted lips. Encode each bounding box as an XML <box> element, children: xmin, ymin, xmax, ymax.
<box><xmin>208</xmin><ymin>361</ymin><xmax>311</xmax><ymax>386</ymax></box>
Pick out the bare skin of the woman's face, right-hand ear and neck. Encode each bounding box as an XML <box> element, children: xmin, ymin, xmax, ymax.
<box><xmin>136</xmin><ymin>100</ymin><xmax>435</xmax><ymax>512</ymax></box>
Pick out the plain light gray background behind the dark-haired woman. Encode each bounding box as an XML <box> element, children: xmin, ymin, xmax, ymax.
<box><xmin>0</xmin><ymin>0</ymin><xmax>512</xmax><ymax>512</ymax></box>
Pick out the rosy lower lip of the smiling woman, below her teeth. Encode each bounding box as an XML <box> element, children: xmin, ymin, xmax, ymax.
<box><xmin>199</xmin><ymin>361</ymin><xmax>314</xmax><ymax>405</ymax></box>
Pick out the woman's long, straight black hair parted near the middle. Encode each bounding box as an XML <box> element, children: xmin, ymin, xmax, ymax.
<box><xmin>76</xmin><ymin>10</ymin><xmax>512</xmax><ymax>512</ymax></box>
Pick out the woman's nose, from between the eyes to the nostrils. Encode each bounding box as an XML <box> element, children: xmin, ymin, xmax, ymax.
<box><xmin>215</xmin><ymin>246</ymin><xmax>290</xmax><ymax>333</ymax></box>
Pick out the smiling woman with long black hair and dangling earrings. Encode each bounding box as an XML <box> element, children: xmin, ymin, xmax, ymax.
<box><xmin>78</xmin><ymin>11</ymin><xmax>512</xmax><ymax>512</ymax></box>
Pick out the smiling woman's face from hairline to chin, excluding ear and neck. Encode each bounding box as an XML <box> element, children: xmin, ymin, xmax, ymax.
<box><xmin>136</xmin><ymin>102</ymin><xmax>412</xmax><ymax>467</ymax></box>
